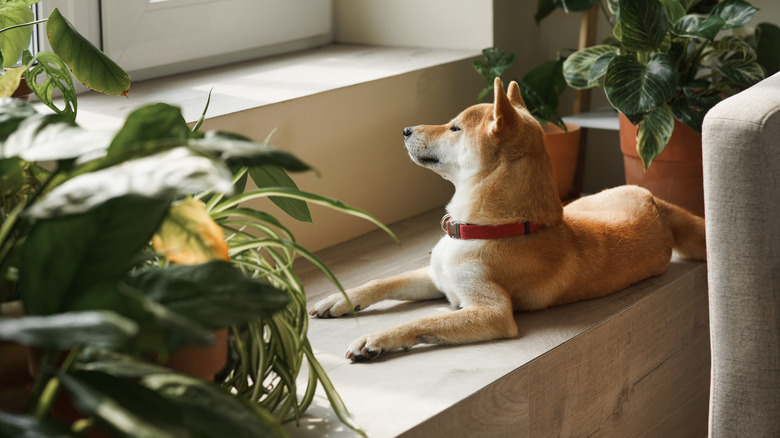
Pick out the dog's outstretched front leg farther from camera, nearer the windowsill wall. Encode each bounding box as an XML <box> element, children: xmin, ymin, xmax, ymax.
<box><xmin>309</xmin><ymin>266</ymin><xmax>444</xmax><ymax>318</ymax></box>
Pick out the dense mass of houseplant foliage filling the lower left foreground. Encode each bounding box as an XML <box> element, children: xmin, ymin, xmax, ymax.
<box><xmin>0</xmin><ymin>99</ymin><xmax>390</xmax><ymax>437</ymax></box>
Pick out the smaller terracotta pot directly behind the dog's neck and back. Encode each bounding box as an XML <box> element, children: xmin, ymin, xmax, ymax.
<box><xmin>542</xmin><ymin>123</ymin><xmax>580</xmax><ymax>200</ymax></box>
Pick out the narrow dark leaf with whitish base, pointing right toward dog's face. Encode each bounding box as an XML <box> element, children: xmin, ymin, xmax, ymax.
<box><xmin>188</xmin><ymin>131</ymin><xmax>312</xmax><ymax>172</ymax></box>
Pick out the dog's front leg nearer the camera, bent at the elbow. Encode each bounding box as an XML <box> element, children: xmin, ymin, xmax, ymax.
<box><xmin>347</xmin><ymin>284</ymin><xmax>517</xmax><ymax>361</ymax></box>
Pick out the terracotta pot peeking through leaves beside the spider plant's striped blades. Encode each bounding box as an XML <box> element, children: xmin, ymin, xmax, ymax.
<box><xmin>165</xmin><ymin>328</ymin><xmax>228</xmax><ymax>382</ymax></box>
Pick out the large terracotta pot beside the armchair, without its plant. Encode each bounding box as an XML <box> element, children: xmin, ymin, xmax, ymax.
<box><xmin>619</xmin><ymin>114</ymin><xmax>704</xmax><ymax>217</ymax></box>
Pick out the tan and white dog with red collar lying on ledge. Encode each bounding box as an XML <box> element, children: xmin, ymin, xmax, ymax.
<box><xmin>310</xmin><ymin>78</ymin><xmax>706</xmax><ymax>361</ymax></box>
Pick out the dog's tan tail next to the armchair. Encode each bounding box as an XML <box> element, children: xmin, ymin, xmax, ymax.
<box><xmin>655</xmin><ymin>198</ymin><xmax>707</xmax><ymax>260</ymax></box>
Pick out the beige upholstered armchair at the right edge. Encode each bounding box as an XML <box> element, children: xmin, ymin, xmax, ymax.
<box><xmin>703</xmin><ymin>73</ymin><xmax>780</xmax><ymax>437</ymax></box>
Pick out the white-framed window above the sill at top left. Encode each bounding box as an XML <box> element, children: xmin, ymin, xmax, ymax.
<box><xmin>40</xmin><ymin>0</ymin><xmax>333</xmax><ymax>80</ymax></box>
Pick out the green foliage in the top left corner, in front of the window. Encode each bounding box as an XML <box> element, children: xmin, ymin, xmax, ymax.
<box><xmin>0</xmin><ymin>0</ymin><xmax>130</xmax><ymax>120</ymax></box>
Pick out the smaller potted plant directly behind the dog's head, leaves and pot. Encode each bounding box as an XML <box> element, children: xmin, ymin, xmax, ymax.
<box><xmin>473</xmin><ymin>47</ymin><xmax>580</xmax><ymax>200</ymax></box>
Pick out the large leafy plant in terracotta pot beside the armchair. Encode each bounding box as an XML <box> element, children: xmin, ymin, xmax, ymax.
<box><xmin>563</xmin><ymin>0</ymin><xmax>777</xmax><ymax>215</ymax></box>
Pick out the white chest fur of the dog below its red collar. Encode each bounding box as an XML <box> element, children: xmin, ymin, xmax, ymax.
<box><xmin>430</xmin><ymin>236</ymin><xmax>484</xmax><ymax>307</ymax></box>
